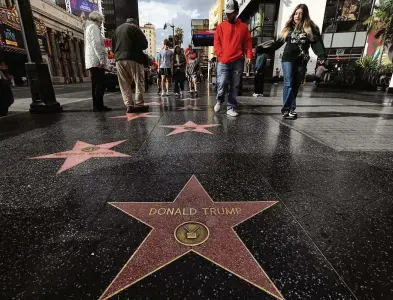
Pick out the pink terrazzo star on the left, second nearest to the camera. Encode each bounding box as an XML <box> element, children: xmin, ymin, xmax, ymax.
<box><xmin>31</xmin><ymin>140</ymin><xmax>129</xmax><ymax>174</ymax></box>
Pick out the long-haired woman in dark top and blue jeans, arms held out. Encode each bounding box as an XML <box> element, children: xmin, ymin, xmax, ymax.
<box><xmin>257</xmin><ymin>4</ymin><xmax>327</xmax><ymax>119</ymax></box>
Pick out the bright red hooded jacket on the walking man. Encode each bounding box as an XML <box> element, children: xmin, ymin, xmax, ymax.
<box><xmin>214</xmin><ymin>19</ymin><xmax>252</xmax><ymax>64</ymax></box>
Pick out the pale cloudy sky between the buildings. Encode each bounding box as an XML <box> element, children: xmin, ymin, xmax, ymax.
<box><xmin>138</xmin><ymin>0</ymin><xmax>216</xmax><ymax>48</ymax></box>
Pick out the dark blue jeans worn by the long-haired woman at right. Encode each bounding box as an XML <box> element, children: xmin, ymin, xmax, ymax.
<box><xmin>281</xmin><ymin>61</ymin><xmax>307</xmax><ymax>112</ymax></box>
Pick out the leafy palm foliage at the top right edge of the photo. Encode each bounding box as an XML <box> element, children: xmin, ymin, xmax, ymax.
<box><xmin>364</xmin><ymin>0</ymin><xmax>393</xmax><ymax>62</ymax></box>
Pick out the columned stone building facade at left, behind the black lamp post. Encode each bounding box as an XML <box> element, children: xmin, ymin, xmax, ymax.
<box><xmin>0</xmin><ymin>0</ymin><xmax>90</xmax><ymax>83</ymax></box>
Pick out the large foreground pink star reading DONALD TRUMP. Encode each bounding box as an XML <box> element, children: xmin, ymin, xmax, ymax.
<box><xmin>100</xmin><ymin>176</ymin><xmax>284</xmax><ymax>300</ymax></box>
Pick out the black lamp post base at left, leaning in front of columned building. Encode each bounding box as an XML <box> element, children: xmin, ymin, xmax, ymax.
<box><xmin>15</xmin><ymin>0</ymin><xmax>62</xmax><ymax>113</ymax></box>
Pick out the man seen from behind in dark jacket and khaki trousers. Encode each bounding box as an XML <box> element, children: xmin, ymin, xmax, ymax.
<box><xmin>112</xmin><ymin>18</ymin><xmax>149</xmax><ymax>113</ymax></box>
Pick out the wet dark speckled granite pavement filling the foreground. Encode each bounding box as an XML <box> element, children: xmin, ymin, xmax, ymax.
<box><xmin>0</xmin><ymin>83</ymin><xmax>393</xmax><ymax>300</ymax></box>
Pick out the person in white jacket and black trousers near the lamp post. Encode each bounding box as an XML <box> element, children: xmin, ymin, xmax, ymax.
<box><xmin>85</xmin><ymin>11</ymin><xmax>111</xmax><ymax>111</ymax></box>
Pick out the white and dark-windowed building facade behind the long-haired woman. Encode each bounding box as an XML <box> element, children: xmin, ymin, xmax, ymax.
<box><xmin>239</xmin><ymin>0</ymin><xmax>375</xmax><ymax>74</ymax></box>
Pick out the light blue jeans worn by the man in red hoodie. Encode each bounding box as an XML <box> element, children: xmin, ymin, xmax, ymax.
<box><xmin>217</xmin><ymin>59</ymin><xmax>244</xmax><ymax>109</ymax></box>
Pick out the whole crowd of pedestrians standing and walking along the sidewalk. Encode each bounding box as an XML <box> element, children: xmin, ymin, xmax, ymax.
<box><xmin>0</xmin><ymin>0</ymin><xmax>327</xmax><ymax>119</ymax></box>
